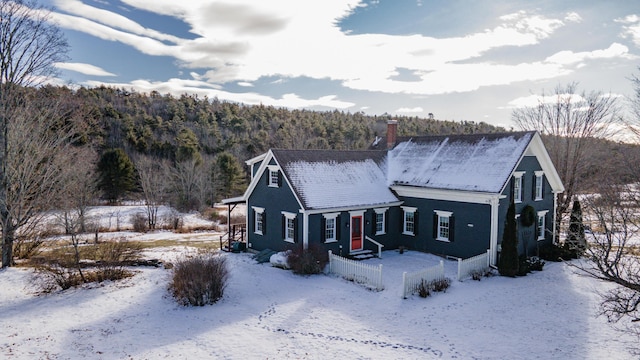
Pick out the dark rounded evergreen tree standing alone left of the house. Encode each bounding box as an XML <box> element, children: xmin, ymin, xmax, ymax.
<box><xmin>98</xmin><ymin>148</ymin><xmax>136</xmax><ymax>203</ymax></box>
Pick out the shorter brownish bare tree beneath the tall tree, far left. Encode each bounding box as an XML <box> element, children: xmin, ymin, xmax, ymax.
<box><xmin>0</xmin><ymin>91</ymin><xmax>78</xmax><ymax>266</ymax></box>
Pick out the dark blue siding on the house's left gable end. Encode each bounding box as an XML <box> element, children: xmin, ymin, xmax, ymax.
<box><xmin>247</xmin><ymin>162</ymin><xmax>302</xmax><ymax>251</ymax></box>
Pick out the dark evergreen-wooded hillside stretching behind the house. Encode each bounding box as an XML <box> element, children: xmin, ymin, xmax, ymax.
<box><xmin>32</xmin><ymin>86</ymin><xmax>638</xmax><ymax>207</ymax></box>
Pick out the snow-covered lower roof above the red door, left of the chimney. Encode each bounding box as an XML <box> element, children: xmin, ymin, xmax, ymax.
<box><xmin>273</xmin><ymin>150</ymin><xmax>398</xmax><ymax>210</ymax></box>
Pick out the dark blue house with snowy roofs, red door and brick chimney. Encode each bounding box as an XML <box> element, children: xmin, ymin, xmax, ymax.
<box><xmin>225</xmin><ymin>121</ymin><xmax>564</xmax><ymax>264</ymax></box>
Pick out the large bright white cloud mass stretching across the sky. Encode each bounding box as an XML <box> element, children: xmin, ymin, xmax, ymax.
<box><xmin>48</xmin><ymin>0</ymin><xmax>630</xmax><ymax>103</ymax></box>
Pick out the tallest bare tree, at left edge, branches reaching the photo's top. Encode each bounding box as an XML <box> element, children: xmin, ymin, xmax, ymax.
<box><xmin>0</xmin><ymin>0</ymin><xmax>69</xmax><ymax>267</ymax></box>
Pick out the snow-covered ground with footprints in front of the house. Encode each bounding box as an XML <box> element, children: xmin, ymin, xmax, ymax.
<box><xmin>0</xmin><ymin>204</ymin><xmax>640</xmax><ymax>359</ymax></box>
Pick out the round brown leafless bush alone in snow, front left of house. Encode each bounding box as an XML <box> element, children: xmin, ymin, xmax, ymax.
<box><xmin>169</xmin><ymin>252</ymin><xmax>229</xmax><ymax>306</ymax></box>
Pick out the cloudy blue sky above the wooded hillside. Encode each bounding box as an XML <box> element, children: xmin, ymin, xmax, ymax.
<box><xmin>40</xmin><ymin>0</ymin><xmax>640</xmax><ymax>128</ymax></box>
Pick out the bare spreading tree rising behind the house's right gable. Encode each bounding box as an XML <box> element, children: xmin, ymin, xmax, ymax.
<box><xmin>511</xmin><ymin>83</ymin><xmax>619</xmax><ymax>236</ymax></box>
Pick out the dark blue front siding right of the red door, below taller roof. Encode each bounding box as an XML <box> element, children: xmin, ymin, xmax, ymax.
<box><xmin>396</xmin><ymin>198</ymin><xmax>491</xmax><ymax>258</ymax></box>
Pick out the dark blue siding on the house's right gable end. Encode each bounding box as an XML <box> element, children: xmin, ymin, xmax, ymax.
<box><xmin>498</xmin><ymin>156</ymin><xmax>554</xmax><ymax>256</ymax></box>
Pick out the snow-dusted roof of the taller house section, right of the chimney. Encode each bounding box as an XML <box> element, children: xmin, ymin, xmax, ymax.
<box><xmin>388</xmin><ymin>132</ymin><xmax>535</xmax><ymax>193</ymax></box>
